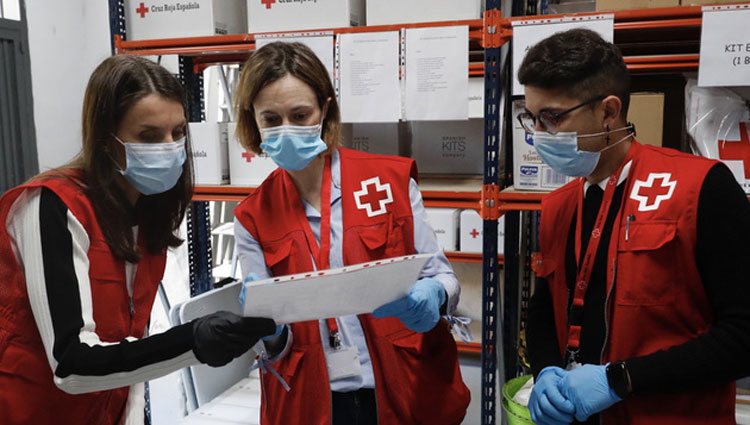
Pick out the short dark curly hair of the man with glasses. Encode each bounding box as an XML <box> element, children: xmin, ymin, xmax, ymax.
<box><xmin>518</xmin><ymin>28</ymin><xmax>630</xmax><ymax>118</ymax></box>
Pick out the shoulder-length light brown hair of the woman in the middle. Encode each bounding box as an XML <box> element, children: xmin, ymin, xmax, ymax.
<box><xmin>235</xmin><ymin>41</ymin><xmax>341</xmax><ymax>154</ymax></box>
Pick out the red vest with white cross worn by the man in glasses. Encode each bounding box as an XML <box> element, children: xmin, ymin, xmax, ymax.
<box><xmin>534</xmin><ymin>142</ymin><xmax>735</xmax><ymax>425</ymax></box>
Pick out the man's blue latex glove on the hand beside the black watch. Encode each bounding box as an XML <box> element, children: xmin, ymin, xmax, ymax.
<box><xmin>559</xmin><ymin>364</ymin><xmax>621</xmax><ymax>422</ymax></box>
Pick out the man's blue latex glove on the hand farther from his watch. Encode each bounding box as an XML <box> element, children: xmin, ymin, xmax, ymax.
<box><xmin>529</xmin><ymin>366</ymin><xmax>575</xmax><ymax>425</ymax></box>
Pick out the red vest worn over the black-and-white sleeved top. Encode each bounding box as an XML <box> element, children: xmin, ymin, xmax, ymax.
<box><xmin>0</xmin><ymin>173</ymin><xmax>166</xmax><ymax>425</ymax></box>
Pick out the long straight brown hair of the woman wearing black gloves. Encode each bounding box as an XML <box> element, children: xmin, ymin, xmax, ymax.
<box><xmin>60</xmin><ymin>55</ymin><xmax>193</xmax><ymax>262</ymax></box>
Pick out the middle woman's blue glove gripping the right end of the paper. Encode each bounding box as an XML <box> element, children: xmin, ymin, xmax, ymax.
<box><xmin>372</xmin><ymin>277</ymin><xmax>447</xmax><ymax>332</ymax></box>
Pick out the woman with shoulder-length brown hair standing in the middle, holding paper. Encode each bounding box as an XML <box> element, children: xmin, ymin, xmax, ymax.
<box><xmin>235</xmin><ymin>42</ymin><xmax>469</xmax><ymax>425</ymax></box>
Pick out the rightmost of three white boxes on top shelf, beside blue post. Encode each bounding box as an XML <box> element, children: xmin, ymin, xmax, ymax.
<box><xmin>368</xmin><ymin>0</ymin><xmax>483</xmax><ymax>25</ymax></box>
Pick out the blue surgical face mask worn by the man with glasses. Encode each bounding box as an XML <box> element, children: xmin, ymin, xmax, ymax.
<box><xmin>533</xmin><ymin>126</ymin><xmax>633</xmax><ymax>177</ymax></box>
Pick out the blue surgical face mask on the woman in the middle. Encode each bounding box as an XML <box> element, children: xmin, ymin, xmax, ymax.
<box><xmin>260</xmin><ymin>118</ymin><xmax>328</xmax><ymax>171</ymax></box>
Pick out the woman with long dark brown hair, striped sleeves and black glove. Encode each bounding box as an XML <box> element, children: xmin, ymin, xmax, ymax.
<box><xmin>0</xmin><ymin>56</ymin><xmax>275</xmax><ymax>424</ymax></box>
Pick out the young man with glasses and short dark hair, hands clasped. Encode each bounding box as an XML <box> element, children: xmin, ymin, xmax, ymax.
<box><xmin>517</xmin><ymin>29</ymin><xmax>750</xmax><ymax>425</ymax></box>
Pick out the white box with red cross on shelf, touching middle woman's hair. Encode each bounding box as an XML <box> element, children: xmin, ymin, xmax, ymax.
<box><xmin>229</xmin><ymin>122</ymin><xmax>277</xmax><ymax>187</ymax></box>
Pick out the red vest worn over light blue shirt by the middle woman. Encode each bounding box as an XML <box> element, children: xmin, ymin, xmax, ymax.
<box><xmin>235</xmin><ymin>148</ymin><xmax>470</xmax><ymax>425</ymax></box>
